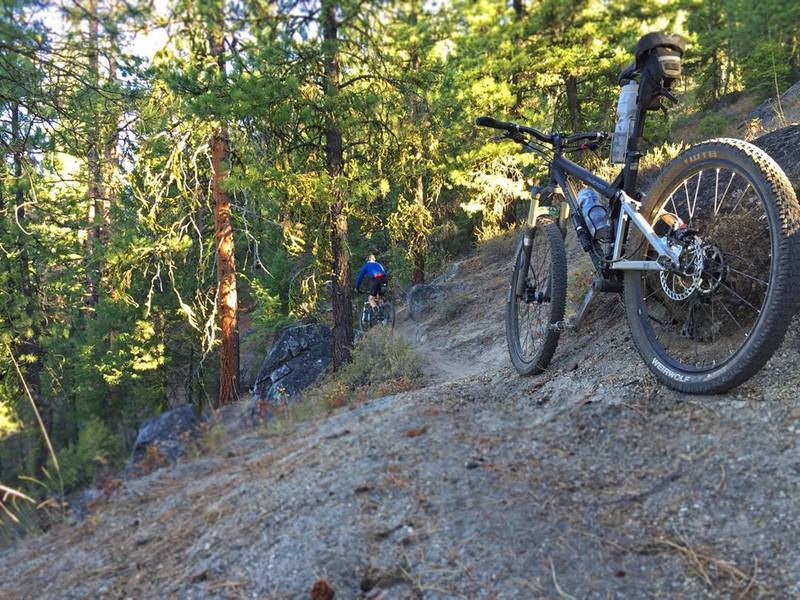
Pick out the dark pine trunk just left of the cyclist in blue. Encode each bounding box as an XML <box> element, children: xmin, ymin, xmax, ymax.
<box><xmin>322</xmin><ymin>1</ymin><xmax>353</xmax><ymax>370</ymax></box>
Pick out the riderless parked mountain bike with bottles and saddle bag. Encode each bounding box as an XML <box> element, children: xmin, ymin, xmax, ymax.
<box><xmin>476</xmin><ymin>33</ymin><xmax>800</xmax><ymax>393</ymax></box>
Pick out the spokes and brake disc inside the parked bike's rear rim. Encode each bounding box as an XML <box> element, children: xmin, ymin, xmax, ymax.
<box><xmin>639</xmin><ymin>163</ymin><xmax>772</xmax><ymax>370</ymax></box>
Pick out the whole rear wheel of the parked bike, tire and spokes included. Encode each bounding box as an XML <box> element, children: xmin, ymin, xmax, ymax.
<box><xmin>625</xmin><ymin>139</ymin><xmax>800</xmax><ymax>394</ymax></box>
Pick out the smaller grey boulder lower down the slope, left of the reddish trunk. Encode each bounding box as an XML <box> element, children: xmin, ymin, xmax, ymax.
<box><xmin>126</xmin><ymin>404</ymin><xmax>200</xmax><ymax>476</ymax></box>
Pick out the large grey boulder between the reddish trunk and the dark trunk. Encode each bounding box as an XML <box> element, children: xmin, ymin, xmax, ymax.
<box><xmin>253</xmin><ymin>323</ymin><xmax>333</xmax><ymax>402</ymax></box>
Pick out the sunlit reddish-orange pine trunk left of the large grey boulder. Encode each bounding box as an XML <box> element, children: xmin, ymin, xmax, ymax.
<box><xmin>209</xmin><ymin>9</ymin><xmax>239</xmax><ymax>406</ymax></box>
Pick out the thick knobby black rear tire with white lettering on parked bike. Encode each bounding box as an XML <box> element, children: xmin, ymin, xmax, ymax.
<box><xmin>624</xmin><ymin>139</ymin><xmax>800</xmax><ymax>394</ymax></box>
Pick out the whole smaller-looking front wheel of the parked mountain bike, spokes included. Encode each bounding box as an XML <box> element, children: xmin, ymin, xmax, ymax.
<box><xmin>506</xmin><ymin>221</ymin><xmax>567</xmax><ymax>376</ymax></box>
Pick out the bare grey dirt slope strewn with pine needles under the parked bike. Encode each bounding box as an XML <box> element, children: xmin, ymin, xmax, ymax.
<box><xmin>0</xmin><ymin>229</ymin><xmax>800</xmax><ymax>599</ymax></box>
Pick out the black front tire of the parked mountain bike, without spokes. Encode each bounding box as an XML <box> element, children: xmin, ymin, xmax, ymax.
<box><xmin>506</xmin><ymin>221</ymin><xmax>567</xmax><ymax>377</ymax></box>
